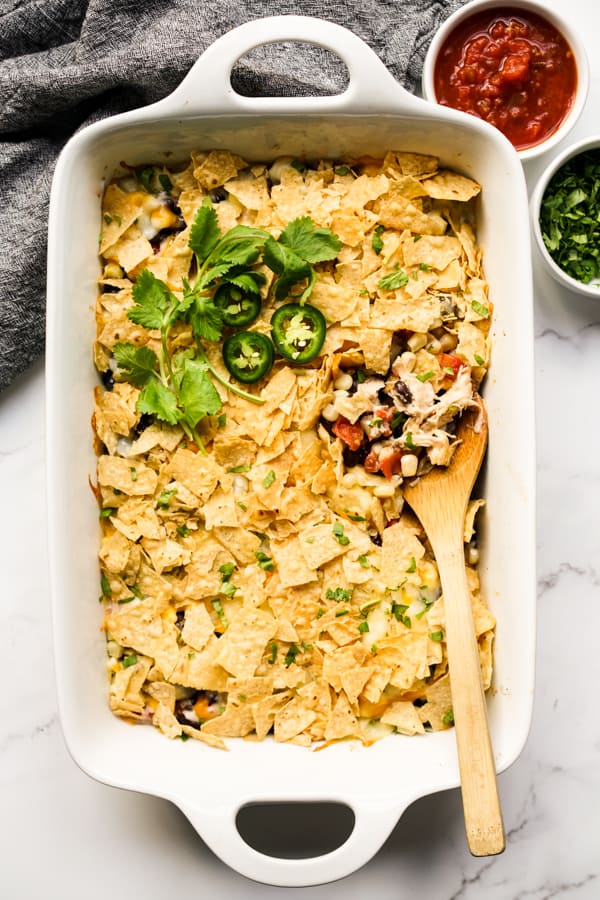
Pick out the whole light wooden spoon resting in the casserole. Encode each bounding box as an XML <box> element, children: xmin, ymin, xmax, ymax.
<box><xmin>403</xmin><ymin>395</ymin><xmax>506</xmax><ymax>856</ymax></box>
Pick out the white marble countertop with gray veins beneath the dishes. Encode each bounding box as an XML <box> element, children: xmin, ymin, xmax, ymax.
<box><xmin>0</xmin><ymin>0</ymin><xmax>600</xmax><ymax>900</ymax></box>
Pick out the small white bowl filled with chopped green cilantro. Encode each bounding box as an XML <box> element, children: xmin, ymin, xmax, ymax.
<box><xmin>531</xmin><ymin>135</ymin><xmax>600</xmax><ymax>299</ymax></box>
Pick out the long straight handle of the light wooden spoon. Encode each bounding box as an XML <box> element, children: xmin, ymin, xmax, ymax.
<box><xmin>434</xmin><ymin>535</ymin><xmax>506</xmax><ymax>856</ymax></box>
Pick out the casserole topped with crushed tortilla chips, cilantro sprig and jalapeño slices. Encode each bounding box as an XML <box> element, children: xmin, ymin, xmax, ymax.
<box><xmin>93</xmin><ymin>150</ymin><xmax>495</xmax><ymax>747</ymax></box>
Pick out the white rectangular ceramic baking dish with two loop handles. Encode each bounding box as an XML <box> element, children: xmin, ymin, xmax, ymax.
<box><xmin>47</xmin><ymin>16</ymin><xmax>535</xmax><ymax>885</ymax></box>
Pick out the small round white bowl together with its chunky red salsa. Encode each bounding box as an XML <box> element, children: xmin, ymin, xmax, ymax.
<box><xmin>423</xmin><ymin>0</ymin><xmax>589</xmax><ymax>161</ymax></box>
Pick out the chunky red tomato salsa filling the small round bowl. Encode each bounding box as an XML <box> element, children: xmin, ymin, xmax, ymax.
<box><xmin>434</xmin><ymin>7</ymin><xmax>577</xmax><ymax>150</ymax></box>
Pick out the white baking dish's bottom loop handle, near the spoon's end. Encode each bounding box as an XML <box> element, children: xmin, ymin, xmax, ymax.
<box><xmin>178</xmin><ymin>792</ymin><xmax>410</xmax><ymax>887</ymax></box>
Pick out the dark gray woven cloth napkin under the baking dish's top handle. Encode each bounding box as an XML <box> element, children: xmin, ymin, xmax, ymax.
<box><xmin>0</xmin><ymin>0</ymin><xmax>463</xmax><ymax>390</ymax></box>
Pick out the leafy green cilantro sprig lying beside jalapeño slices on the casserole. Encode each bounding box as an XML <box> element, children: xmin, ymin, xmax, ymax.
<box><xmin>113</xmin><ymin>200</ymin><xmax>341</xmax><ymax>452</ymax></box>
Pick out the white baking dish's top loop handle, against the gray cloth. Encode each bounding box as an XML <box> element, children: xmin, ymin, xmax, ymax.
<box><xmin>146</xmin><ymin>15</ymin><xmax>428</xmax><ymax>118</ymax></box>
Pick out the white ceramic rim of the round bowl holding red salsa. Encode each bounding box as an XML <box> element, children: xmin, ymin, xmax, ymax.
<box><xmin>421</xmin><ymin>0</ymin><xmax>590</xmax><ymax>162</ymax></box>
